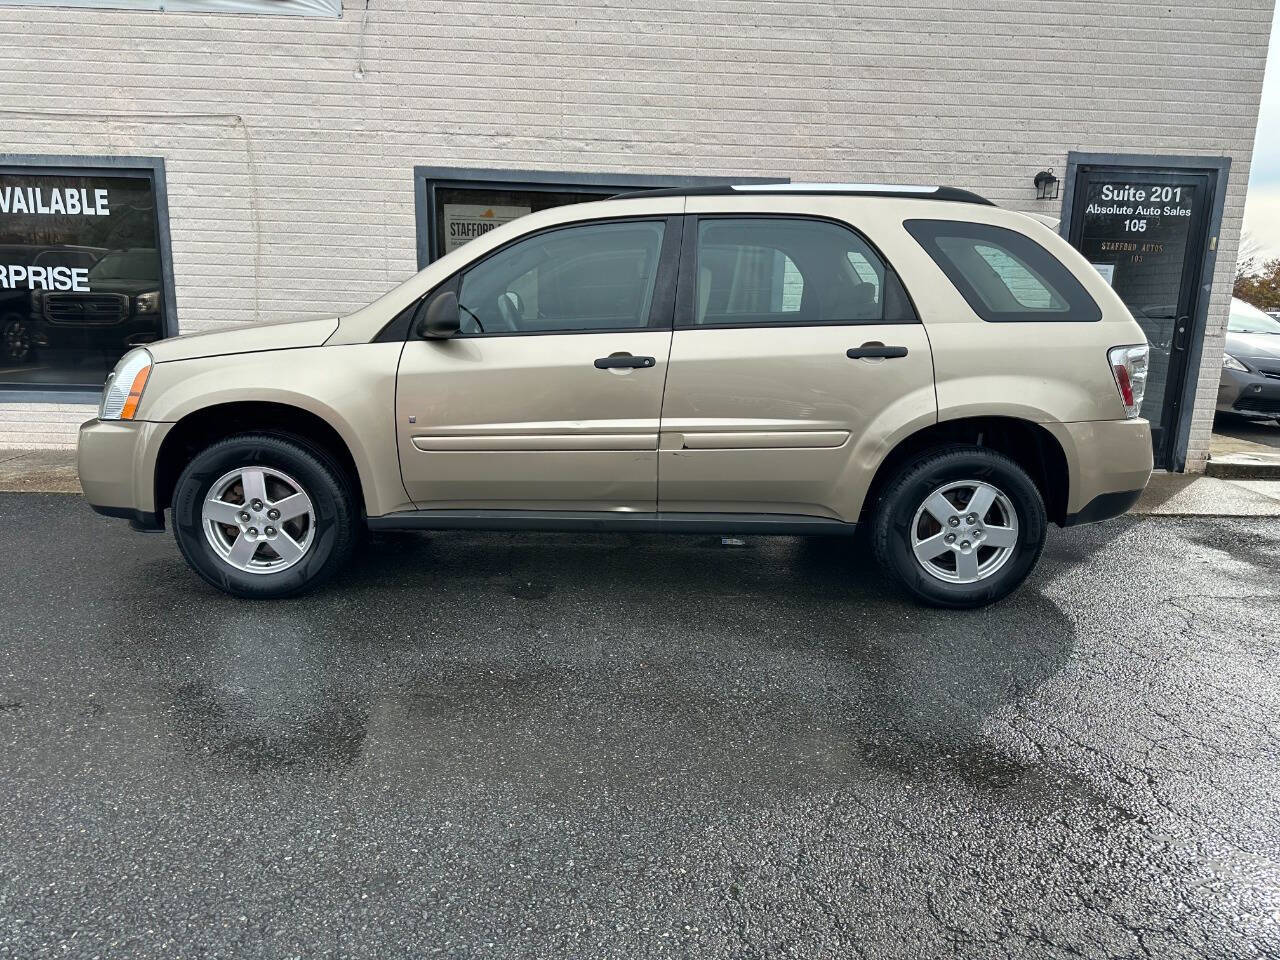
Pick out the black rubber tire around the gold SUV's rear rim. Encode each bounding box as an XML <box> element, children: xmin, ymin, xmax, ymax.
<box><xmin>872</xmin><ymin>444</ymin><xmax>1047</xmax><ymax>609</ymax></box>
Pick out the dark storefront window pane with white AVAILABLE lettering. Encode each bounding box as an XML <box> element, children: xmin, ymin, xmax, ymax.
<box><xmin>0</xmin><ymin>170</ymin><xmax>170</xmax><ymax>387</ymax></box>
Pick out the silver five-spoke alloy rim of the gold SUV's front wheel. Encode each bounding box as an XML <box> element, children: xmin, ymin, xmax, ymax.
<box><xmin>200</xmin><ymin>466</ymin><xmax>316</xmax><ymax>573</ymax></box>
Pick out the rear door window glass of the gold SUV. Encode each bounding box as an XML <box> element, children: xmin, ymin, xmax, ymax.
<box><xmin>686</xmin><ymin>218</ymin><xmax>915</xmax><ymax>326</ymax></box>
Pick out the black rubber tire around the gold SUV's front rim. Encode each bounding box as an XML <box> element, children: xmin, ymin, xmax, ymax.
<box><xmin>173</xmin><ymin>434</ymin><xmax>361</xmax><ymax>599</ymax></box>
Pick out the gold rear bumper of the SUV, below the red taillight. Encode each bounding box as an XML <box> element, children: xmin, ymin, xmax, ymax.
<box><xmin>1044</xmin><ymin>419</ymin><xmax>1153</xmax><ymax>526</ymax></box>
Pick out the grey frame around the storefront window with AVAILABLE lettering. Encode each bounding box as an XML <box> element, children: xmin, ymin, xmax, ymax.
<box><xmin>0</xmin><ymin>154</ymin><xmax>178</xmax><ymax>406</ymax></box>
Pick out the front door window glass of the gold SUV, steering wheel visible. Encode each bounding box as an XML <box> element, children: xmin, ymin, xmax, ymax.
<box><xmin>458</xmin><ymin>220</ymin><xmax>664</xmax><ymax>335</ymax></box>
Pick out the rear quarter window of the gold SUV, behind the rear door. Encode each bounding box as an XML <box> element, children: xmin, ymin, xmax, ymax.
<box><xmin>902</xmin><ymin>220</ymin><xmax>1102</xmax><ymax>323</ymax></box>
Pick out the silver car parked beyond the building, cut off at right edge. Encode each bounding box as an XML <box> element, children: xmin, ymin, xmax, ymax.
<box><xmin>1217</xmin><ymin>297</ymin><xmax>1280</xmax><ymax>420</ymax></box>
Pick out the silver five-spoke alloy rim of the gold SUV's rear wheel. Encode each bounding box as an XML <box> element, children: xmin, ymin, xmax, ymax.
<box><xmin>911</xmin><ymin>480</ymin><xmax>1018</xmax><ymax>584</ymax></box>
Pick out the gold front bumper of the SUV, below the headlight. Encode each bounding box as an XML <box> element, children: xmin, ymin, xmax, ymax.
<box><xmin>76</xmin><ymin>419</ymin><xmax>173</xmax><ymax>530</ymax></box>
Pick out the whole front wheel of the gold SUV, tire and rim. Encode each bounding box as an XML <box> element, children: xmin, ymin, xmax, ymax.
<box><xmin>173</xmin><ymin>434</ymin><xmax>357</xmax><ymax>598</ymax></box>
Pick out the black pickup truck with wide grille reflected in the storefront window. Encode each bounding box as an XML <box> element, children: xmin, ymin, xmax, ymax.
<box><xmin>31</xmin><ymin>247</ymin><xmax>164</xmax><ymax>363</ymax></box>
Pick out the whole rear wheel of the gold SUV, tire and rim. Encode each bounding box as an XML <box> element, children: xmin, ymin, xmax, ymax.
<box><xmin>872</xmin><ymin>445</ymin><xmax>1046</xmax><ymax>608</ymax></box>
